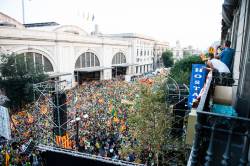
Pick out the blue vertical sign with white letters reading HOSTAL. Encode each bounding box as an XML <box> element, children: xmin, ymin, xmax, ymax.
<box><xmin>188</xmin><ymin>64</ymin><xmax>206</xmax><ymax>108</ymax></box>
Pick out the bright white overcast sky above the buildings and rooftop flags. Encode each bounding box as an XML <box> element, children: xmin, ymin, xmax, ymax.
<box><xmin>0</xmin><ymin>0</ymin><xmax>223</xmax><ymax>50</ymax></box>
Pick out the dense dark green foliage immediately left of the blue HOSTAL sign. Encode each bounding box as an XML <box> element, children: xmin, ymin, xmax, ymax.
<box><xmin>170</xmin><ymin>56</ymin><xmax>204</xmax><ymax>85</ymax></box>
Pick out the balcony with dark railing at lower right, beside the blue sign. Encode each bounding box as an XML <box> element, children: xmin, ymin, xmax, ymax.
<box><xmin>188</xmin><ymin>73</ymin><xmax>250</xmax><ymax>166</ymax></box>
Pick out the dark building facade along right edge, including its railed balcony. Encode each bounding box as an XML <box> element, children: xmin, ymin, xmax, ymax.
<box><xmin>187</xmin><ymin>0</ymin><xmax>250</xmax><ymax>166</ymax></box>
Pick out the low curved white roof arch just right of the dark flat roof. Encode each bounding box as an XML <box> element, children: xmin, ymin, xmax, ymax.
<box><xmin>54</xmin><ymin>25</ymin><xmax>88</xmax><ymax>36</ymax></box>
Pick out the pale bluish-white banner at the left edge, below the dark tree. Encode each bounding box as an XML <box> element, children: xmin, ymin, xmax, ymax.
<box><xmin>0</xmin><ymin>106</ymin><xmax>11</xmax><ymax>140</ymax></box>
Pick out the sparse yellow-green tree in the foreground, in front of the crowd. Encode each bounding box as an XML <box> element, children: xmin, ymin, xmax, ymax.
<box><xmin>123</xmin><ymin>78</ymin><xmax>188</xmax><ymax>165</ymax></box>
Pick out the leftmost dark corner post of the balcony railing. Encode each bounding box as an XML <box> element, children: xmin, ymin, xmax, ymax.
<box><xmin>191</xmin><ymin>114</ymin><xmax>202</xmax><ymax>166</ymax></box>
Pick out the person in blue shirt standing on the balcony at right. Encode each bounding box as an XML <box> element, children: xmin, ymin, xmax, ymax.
<box><xmin>216</xmin><ymin>40</ymin><xmax>235</xmax><ymax>69</ymax></box>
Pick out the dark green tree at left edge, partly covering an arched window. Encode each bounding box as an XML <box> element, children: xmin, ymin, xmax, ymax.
<box><xmin>0</xmin><ymin>54</ymin><xmax>48</xmax><ymax>109</ymax></box>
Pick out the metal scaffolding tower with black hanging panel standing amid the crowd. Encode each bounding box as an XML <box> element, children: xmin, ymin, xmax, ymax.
<box><xmin>32</xmin><ymin>80</ymin><xmax>75</xmax><ymax>146</ymax></box>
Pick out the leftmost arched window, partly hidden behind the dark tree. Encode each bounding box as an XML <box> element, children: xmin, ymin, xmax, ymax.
<box><xmin>16</xmin><ymin>52</ymin><xmax>54</xmax><ymax>72</ymax></box>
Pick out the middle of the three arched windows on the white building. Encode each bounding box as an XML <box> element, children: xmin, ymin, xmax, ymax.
<box><xmin>75</xmin><ymin>52</ymin><xmax>100</xmax><ymax>69</ymax></box>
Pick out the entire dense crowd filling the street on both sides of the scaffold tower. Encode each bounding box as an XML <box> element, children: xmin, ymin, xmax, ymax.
<box><xmin>1</xmin><ymin>77</ymin><xmax>158</xmax><ymax>163</ymax></box>
